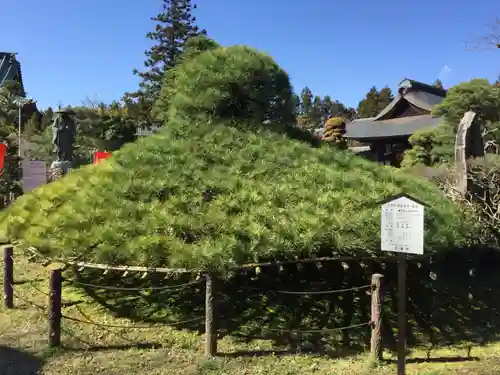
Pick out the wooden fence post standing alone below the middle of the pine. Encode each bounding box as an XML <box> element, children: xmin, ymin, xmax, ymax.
<box><xmin>205</xmin><ymin>273</ymin><xmax>217</xmax><ymax>357</ymax></box>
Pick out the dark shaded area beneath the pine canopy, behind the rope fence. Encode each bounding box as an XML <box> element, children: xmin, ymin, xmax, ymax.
<box><xmin>71</xmin><ymin>249</ymin><xmax>500</xmax><ymax>358</ymax></box>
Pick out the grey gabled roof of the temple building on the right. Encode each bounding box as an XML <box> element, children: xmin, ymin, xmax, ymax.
<box><xmin>344</xmin><ymin>79</ymin><xmax>446</xmax><ymax>140</ymax></box>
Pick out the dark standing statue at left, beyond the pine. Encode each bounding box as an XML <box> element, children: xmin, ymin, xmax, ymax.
<box><xmin>52</xmin><ymin>108</ymin><xmax>76</xmax><ymax>162</ymax></box>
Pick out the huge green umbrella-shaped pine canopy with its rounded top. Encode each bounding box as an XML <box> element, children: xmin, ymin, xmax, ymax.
<box><xmin>0</xmin><ymin>42</ymin><xmax>471</xmax><ymax>270</ymax></box>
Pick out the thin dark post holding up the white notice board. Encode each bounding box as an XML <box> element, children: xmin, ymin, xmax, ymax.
<box><xmin>397</xmin><ymin>253</ymin><xmax>406</xmax><ymax>375</ymax></box>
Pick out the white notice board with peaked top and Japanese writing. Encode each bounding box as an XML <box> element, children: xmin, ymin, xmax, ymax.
<box><xmin>380</xmin><ymin>196</ymin><xmax>424</xmax><ymax>254</ymax></box>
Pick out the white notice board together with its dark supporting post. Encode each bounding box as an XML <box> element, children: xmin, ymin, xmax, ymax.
<box><xmin>380</xmin><ymin>194</ymin><xmax>425</xmax><ymax>375</ymax></box>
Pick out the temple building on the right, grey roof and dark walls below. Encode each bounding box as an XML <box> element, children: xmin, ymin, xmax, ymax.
<box><xmin>317</xmin><ymin>79</ymin><xmax>446</xmax><ymax>167</ymax></box>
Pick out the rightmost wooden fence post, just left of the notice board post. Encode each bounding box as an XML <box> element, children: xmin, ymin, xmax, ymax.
<box><xmin>370</xmin><ymin>274</ymin><xmax>384</xmax><ymax>361</ymax></box>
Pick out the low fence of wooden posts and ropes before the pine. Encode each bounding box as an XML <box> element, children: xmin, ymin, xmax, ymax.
<box><xmin>3</xmin><ymin>246</ymin><xmax>384</xmax><ymax>360</ymax></box>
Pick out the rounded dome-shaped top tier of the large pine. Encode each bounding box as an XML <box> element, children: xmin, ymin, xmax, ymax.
<box><xmin>164</xmin><ymin>46</ymin><xmax>294</xmax><ymax>126</ymax></box>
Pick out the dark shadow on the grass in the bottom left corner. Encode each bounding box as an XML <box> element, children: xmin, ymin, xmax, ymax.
<box><xmin>0</xmin><ymin>345</ymin><xmax>43</xmax><ymax>375</ymax></box>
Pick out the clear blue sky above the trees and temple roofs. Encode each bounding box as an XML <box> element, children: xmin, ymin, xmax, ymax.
<box><xmin>0</xmin><ymin>0</ymin><xmax>500</xmax><ymax>108</ymax></box>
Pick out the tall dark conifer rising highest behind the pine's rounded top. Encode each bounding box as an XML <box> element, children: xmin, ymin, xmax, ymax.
<box><xmin>126</xmin><ymin>0</ymin><xmax>206</xmax><ymax>106</ymax></box>
